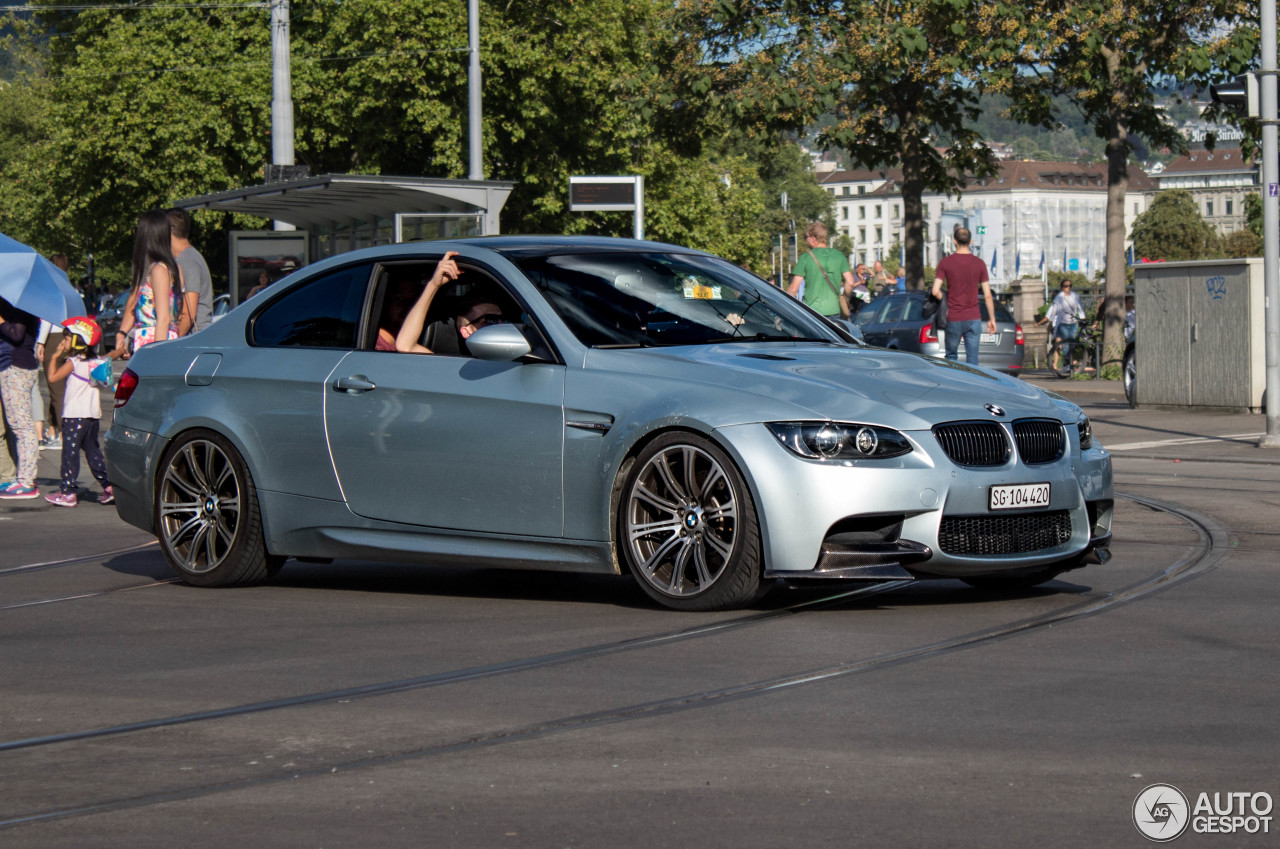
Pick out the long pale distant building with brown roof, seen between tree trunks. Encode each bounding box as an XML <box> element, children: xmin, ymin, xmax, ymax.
<box><xmin>817</xmin><ymin>161</ymin><xmax>1157</xmax><ymax>288</ymax></box>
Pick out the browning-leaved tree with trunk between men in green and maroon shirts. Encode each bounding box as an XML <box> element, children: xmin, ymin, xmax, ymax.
<box><xmin>672</xmin><ymin>0</ymin><xmax>1002</xmax><ymax>286</ymax></box>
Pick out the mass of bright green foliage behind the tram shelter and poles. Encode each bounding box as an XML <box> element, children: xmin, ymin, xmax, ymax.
<box><xmin>0</xmin><ymin>0</ymin><xmax>798</xmax><ymax>274</ymax></box>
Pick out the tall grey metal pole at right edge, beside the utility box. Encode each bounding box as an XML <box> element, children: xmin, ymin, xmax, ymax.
<box><xmin>1258</xmin><ymin>0</ymin><xmax>1280</xmax><ymax>448</ymax></box>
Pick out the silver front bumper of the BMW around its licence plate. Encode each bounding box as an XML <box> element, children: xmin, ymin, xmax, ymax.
<box><xmin>717</xmin><ymin>424</ymin><xmax>1112</xmax><ymax>580</ymax></box>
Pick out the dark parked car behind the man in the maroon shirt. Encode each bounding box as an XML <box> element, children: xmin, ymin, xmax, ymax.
<box><xmin>852</xmin><ymin>291</ymin><xmax>1025</xmax><ymax>374</ymax></box>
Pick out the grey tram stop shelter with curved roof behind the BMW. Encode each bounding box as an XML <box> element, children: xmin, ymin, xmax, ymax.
<box><xmin>175</xmin><ymin>174</ymin><xmax>515</xmax><ymax>302</ymax></box>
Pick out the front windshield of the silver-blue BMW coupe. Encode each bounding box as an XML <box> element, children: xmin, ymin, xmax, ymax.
<box><xmin>517</xmin><ymin>252</ymin><xmax>844</xmax><ymax>347</ymax></box>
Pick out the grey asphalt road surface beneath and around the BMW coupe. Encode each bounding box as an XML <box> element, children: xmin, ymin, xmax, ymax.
<box><xmin>0</xmin><ymin>382</ymin><xmax>1280</xmax><ymax>849</ymax></box>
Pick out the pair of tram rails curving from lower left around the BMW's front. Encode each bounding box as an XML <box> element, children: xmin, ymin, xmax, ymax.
<box><xmin>0</xmin><ymin>493</ymin><xmax>1231</xmax><ymax>829</ymax></box>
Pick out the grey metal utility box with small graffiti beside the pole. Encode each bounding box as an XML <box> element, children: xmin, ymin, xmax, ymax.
<box><xmin>1134</xmin><ymin>259</ymin><xmax>1266</xmax><ymax>412</ymax></box>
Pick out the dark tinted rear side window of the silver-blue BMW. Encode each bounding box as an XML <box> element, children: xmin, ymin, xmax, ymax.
<box><xmin>252</xmin><ymin>265</ymin><xmax>370</xmax><ymax>348</ymax></box>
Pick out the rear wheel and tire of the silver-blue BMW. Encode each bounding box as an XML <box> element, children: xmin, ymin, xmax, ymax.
<box><xmin>155</xmin><ymin>430</ymin><xmax>284</xmax><ymax>586</ymax></box>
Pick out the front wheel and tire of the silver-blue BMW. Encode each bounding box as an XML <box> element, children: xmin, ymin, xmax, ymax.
<box><xmin>617</xmin><ymin>433</ymin><xmax>764</xmax><ymax>611</ymax></box>
